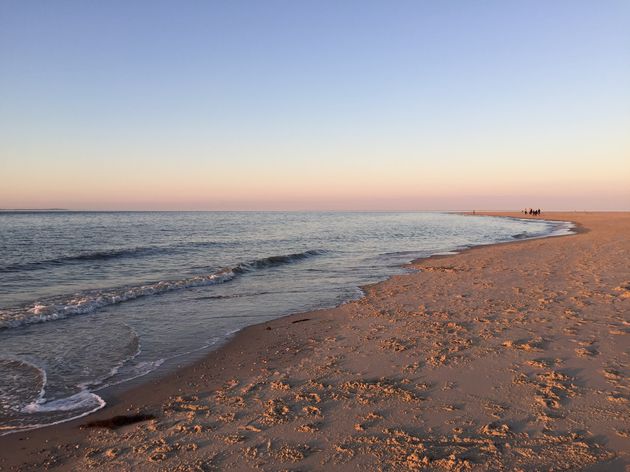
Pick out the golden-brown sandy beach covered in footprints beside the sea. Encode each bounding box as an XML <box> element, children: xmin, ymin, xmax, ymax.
<box><xmin>0</xmin><ymin>213</ymin><xmax>630</xmax><ymax>471</ymax></box>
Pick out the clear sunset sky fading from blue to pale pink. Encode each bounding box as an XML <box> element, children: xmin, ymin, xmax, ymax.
<box><xmin>0</xmin><ymin>0</ymin><xmax>630</xmax><ymax>210</ymax></box>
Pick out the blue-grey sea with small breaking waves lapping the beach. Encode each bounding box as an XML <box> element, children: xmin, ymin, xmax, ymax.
<box><xmin>0</xmin><ymin>212</ymin><xmax>570</xmax><ymax>434</ymax></box>
